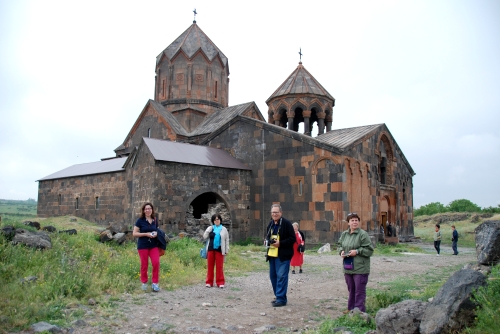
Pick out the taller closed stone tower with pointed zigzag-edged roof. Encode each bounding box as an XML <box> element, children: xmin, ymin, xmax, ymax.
<box><xmin>154</xmin><ymin>21</ymin><xmax>229</xmax><ymax>132</ymax></box>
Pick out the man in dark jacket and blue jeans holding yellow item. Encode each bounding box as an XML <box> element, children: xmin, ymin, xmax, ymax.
<box><xmin>264</xmin><ymin>204</ymin><xmax>295</xmax><ymax>307</ymax></box>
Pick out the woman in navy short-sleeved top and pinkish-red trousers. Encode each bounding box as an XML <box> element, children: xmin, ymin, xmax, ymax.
<box><xmin>132</xmin><ymin>202</ymin><xmax>160</xmax><ymax>292</ymax></box>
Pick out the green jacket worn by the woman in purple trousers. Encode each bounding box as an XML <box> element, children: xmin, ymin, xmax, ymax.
<box><xmin>338</xmin><ymin>228</ymin><xmax>373</xmax><ymax>274</ymax></box>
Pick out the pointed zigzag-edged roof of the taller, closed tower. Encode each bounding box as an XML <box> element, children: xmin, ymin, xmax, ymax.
<box><xmin>156</xmin><ymin>22</ymin><xmax>229</xmax><ymax>70</ymax></box>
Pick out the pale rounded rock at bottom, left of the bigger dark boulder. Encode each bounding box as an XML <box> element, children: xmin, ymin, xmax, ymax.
<box><xmin>375</xmin><ymin>300</ymin><xmax>427</xmax><ymax>334</ymax></box>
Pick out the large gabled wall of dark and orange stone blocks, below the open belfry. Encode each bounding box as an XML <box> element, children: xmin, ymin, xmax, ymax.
<box><xmin>205</xmin><ymin>118</ymin><xmax>413</xmax><ymax>243</ymax></box>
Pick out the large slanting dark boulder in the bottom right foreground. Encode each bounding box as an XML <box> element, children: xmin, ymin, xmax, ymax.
<box><xmin>420</xmin><ymin>269</ymin><xmax>486</xmax><ymax>334</ymax></box>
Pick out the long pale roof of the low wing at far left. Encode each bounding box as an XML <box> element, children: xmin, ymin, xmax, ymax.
<box><xmin>38</xmin><ymin>157</ymin><xmax>127</xmax><ymax>181</ymax></box>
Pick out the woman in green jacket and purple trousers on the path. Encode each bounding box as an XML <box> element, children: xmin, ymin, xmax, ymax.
<box><xmin>339</xmin><ymin>212</ymin><xmax>373</xmax><ymax>313</ymax></box>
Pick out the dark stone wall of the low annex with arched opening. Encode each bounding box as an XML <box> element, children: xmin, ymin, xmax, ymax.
<box><xmin>129</xmin><ymin>145</ymin><xmax>251</xmax><ymax>241</ymax></box>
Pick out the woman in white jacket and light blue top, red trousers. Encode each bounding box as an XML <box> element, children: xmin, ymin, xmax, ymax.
<box><xmin>203</xmin><ymin>214</ymin><xmax>229</xmax><ymax>289</ymax></box>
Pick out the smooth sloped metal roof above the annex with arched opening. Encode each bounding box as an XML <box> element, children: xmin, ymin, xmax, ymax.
<box><xmin>143</xmin><ymin>137</ymin><xmax>250</xmax><ymax>170</ymax></box>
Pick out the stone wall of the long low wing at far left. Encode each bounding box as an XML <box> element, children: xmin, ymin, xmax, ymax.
<box><xmin>37</xmin><ymin>172</ymin><xmax>128</xmax><ymax>224</ymax></box>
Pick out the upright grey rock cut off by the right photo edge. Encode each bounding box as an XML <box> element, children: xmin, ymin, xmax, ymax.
<box><xmin>475</xmin><ymin>220</ymin><xmax>500</xmax><ymax>265</ymax></box>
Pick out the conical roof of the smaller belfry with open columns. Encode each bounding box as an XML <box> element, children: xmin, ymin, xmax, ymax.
<box><xmin>266</xmin><ymin>62</ymin><xmax>335</xmax><ymax>103</ymax></box>
